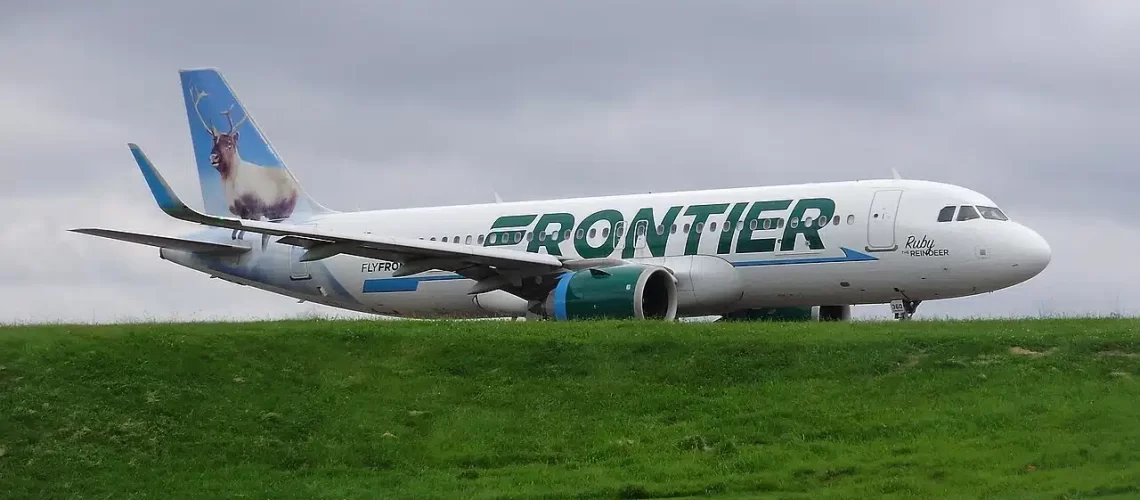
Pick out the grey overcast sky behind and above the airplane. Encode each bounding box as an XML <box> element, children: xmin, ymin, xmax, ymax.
<box><xmin>0</xmin><ymin>0</ymin><xmax>1140</xmax><ymax>322</ymax></box>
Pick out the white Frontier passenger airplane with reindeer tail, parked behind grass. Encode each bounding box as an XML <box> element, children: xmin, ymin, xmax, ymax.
<box><xmin>72</xmin><ymin>68</ymin><xmax>1051</xmax><ymax>321</ymax></box>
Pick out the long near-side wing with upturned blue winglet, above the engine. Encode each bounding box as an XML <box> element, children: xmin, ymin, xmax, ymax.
<box><xmin>120</xmin><ymin>144</ymin><xmax>567</xmax><ymax>296</ymax></box>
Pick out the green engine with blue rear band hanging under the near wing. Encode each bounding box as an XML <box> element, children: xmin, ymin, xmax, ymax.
<box><xmin>542</xmin><ymin>264</ymin><xmax>677</xmax><ymax>321</ymax></box>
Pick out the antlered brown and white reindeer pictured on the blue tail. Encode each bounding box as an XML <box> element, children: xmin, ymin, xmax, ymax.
<box><xmin>190</xmin><ymin>88</ymin><xmax>299</xmax><ymax>249</ymax></box>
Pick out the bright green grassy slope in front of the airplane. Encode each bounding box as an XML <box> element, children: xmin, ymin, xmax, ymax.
<box><xmin>0</xmin><ymin>319</ymin><xmax>1140</xmax><ymax>499</ymax></box>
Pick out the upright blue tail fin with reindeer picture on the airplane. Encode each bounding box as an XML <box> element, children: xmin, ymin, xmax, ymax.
<box><xmin>179</xmin><ymin>68</ymin><xmax>331</xmax><ymax>221</ymax></box>
